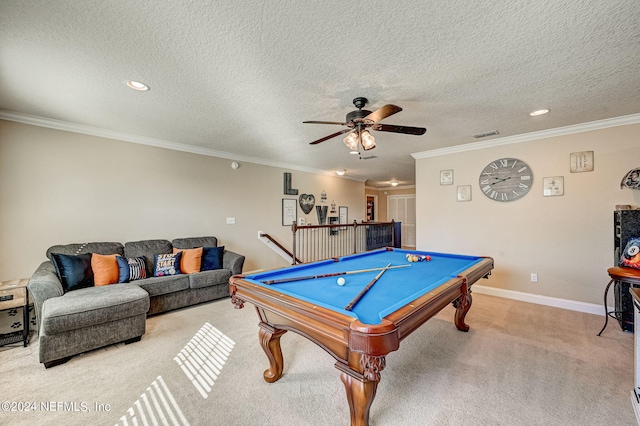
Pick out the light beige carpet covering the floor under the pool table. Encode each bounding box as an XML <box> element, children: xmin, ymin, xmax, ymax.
<box><xmin>0</xmin><ymin>294</ymin><xmax>636</xmax><ymax>426</ymax></box>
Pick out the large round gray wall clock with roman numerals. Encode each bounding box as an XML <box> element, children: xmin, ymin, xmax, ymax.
<box><xmin>478</xmin><ymin>158</ymin><xmax>533</xmax><ymax>202</ymax></box>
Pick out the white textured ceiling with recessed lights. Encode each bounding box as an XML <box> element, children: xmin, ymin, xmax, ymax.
<box><xmin>0</xmin><ymin>0</ymin><xmax>640</xmax><ymax>186</ymax></box>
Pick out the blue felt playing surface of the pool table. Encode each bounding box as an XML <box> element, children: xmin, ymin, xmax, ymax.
<box><xmin>245</xmin><ymin>249</ymin><xmax>483</xmax><ymax>324</ymax></box>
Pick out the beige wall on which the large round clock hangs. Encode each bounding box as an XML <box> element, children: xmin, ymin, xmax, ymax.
<box><xmin>416</xmin><ymin>125</ymin><xmax>640</xmax><ymax>304</ymax></box>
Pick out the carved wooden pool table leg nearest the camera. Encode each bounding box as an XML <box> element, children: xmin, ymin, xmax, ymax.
<box><xmin>336</xmin><ymin>355</ymin><xmax>386</xmax><ymax>426</ymax></box>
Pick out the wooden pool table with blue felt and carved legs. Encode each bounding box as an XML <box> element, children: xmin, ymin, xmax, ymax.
<box><xmin>229</xmin><ymin>248</ymin><xmax>493</xmax><ymax>426</ymax></box>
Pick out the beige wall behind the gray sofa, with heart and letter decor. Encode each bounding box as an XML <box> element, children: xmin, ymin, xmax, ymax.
<box><xmin>0</xmin><ymin>120</ymin><xmax>364</xmax><ymax>280</ymax></box>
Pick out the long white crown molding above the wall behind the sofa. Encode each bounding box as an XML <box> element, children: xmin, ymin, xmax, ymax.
<box><xmin>0</xmin><ymin>110</ymin><xmax>366</xmax><ymax>182</ymax></box>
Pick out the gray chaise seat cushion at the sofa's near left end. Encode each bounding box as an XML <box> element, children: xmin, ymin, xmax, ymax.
<box><xmin>40</xmin><ymin>285</ymin><xmax>149</xmax><ymax>335</ymax></box>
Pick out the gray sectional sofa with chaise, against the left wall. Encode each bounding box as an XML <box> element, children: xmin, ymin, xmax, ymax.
<box><xmin>28</xmin><ymin>237</ymin><xmax>244</xmax><ymax>368</ymax></box>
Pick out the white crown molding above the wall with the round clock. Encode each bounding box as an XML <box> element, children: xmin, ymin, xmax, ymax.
<box><xmin>411</xmin><ymin>114</ymin><xmax>640</xmax><ymax>160</ymax></box>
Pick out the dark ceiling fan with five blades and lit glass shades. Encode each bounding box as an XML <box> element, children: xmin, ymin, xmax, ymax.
<box><xmin>303</xmin><ymin>97</ymin><xmax>427</xmax><ymax>151</ymax></box>
